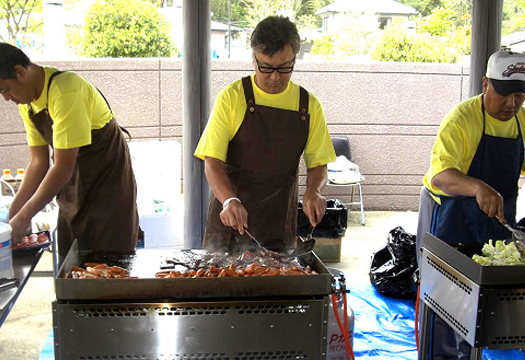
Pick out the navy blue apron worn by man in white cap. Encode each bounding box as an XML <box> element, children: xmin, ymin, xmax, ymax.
<box><xmin>428</xmin><ymin>98</ymin><xmax>523</xmax><ymax>360</ymax></box>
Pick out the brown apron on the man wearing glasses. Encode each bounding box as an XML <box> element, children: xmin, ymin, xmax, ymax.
<box><xmin>203</xmin><ymin>77</ymin><xmax>310</xmax><ymax>252</ymax></box>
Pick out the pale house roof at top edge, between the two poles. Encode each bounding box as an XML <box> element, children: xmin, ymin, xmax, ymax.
<box><xmin>316</xmin><ymin>0</ymin><xmax>418</xmax><ymax>15</ymax></box>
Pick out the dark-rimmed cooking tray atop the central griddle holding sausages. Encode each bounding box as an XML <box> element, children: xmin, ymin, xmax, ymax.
<box><xmin>55</xmin><ymin>241</ymin><xmax>331</xmax><ymax>301</ymax></box>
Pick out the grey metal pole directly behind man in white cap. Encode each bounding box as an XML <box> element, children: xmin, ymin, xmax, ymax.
<box><xmin>469</xmin><ymin>0</ymin><xmax>503</xmax><ymax>97</ymax></box>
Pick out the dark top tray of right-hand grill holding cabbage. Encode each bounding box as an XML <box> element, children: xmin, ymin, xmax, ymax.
<box><xmin>423</xmin><ymin>233</ymin><xmax>525</xmax><ymax>286</ymax></box>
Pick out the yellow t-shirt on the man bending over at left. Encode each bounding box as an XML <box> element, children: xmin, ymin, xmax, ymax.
<box><xmin>18</xmin><ymin>67</ymin><xmax>113</xmax><ymax>149</ymax></box>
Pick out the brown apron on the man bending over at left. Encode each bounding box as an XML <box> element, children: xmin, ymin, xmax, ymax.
<box><xmin>29</xmin><ymin>72</ymin><xmax>139</xmax><ymax>256</ymax></box>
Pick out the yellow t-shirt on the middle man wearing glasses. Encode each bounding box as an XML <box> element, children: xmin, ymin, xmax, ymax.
<box><xmin>195</xmin><ymin>75</ymin><xmax>336</xmax><ymax>169</ymax></box>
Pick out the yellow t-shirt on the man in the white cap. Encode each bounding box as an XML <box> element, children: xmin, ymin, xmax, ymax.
<box><xmin>423</xmin><ymin>95</ymin><xmax>525</xmax><ymax>195</ymax></box>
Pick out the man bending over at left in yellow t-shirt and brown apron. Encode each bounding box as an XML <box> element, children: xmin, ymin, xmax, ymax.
<box><xmin>0</xmin><ymin>43</ymin><xmax>139</xmax><ymax>257</ymax></box>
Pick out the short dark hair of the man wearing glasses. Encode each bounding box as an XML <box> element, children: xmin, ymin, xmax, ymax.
<box><xmin>251</xmin><ymin>16</ymin><xmax>301</xmax><ymax>56</ymax></box>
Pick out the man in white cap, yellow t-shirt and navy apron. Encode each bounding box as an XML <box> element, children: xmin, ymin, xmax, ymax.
<box><xmin>417</xmin><ymin>51</ymin><xmax>525</xmax><ymax>359</ymax></box>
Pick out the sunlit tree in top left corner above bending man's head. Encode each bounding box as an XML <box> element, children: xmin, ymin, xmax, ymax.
<box><xmin>0</xmin><ymin>0</ymin><xmax>43</xmax><ymax>45</ymax></box>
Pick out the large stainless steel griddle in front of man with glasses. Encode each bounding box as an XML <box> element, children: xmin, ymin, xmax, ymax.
<box><xmin>53</xmin><ymin>239</ymin><xmax>332</xmax><ymax>360</ymax></box>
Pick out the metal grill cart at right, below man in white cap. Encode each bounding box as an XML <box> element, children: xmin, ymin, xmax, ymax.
<box><xmin>419</xmin><ymin>233</ymin><xmax>525</xmax><ymax>359</ymax></box>
